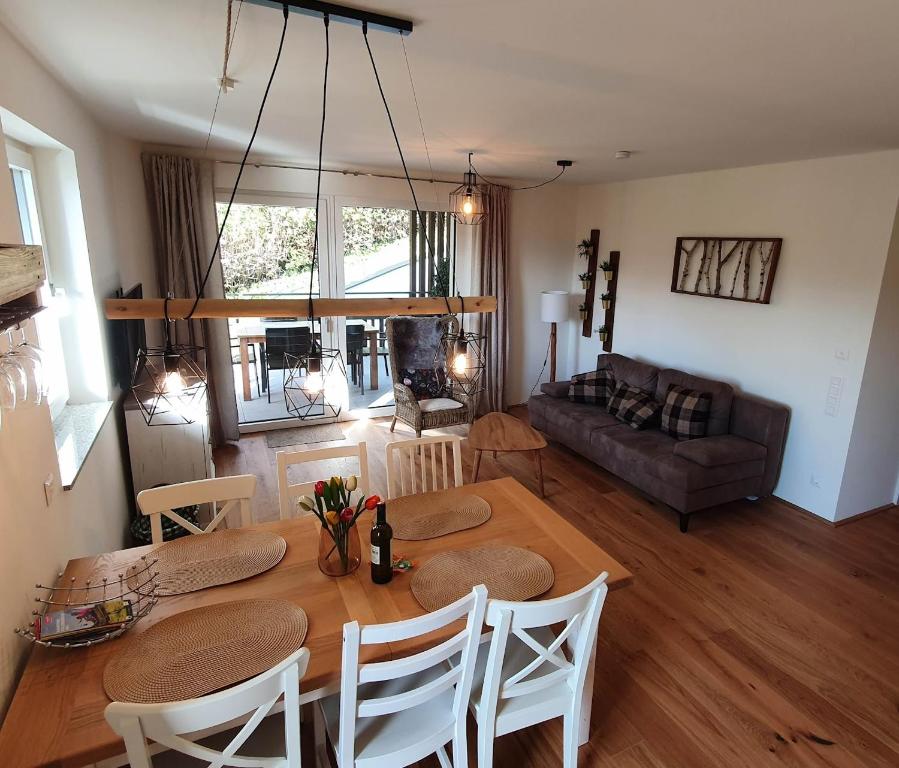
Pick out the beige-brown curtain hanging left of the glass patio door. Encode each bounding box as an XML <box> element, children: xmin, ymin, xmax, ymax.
<box><xmin>143</xmin><ymin>154</ymin><xmax>240</xmax><ymax>445</ymax></box>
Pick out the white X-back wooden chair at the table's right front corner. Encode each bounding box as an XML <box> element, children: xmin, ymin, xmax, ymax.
<box><xmin>464</xmin><ymin>572</ymin><xmax>609</xmax><ymax>768</ymax></box>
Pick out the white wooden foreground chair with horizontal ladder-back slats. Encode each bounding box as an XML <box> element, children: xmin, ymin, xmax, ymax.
<box><xmin>315</xmin><ymin>585</ymin><xmax>487</xmax><ymax>768</ymax></box>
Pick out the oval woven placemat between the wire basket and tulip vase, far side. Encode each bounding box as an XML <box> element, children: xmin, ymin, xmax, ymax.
<box><xmin>132</xmin><ymin>528</ymin><xmax>287</xmax><ymax>596</ymax></box>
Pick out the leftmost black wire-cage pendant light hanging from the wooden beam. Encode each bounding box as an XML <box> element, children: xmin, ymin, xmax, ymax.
<box><xmin>131</xmin><ymin>295</ymin><xmax>206</xmax><ymax>426</ymax></box>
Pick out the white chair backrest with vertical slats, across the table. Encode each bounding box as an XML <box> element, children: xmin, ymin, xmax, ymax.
<box><xmin>387</xmin><ymin>435</ymin><xmax>463</xmax><ymax>499</ymax></box>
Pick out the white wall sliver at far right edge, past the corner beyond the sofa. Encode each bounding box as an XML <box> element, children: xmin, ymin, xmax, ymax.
<box><xmin>835</xmin><ymin>198</ymin><xmax>899</xmax><ymax>520</ymax></box>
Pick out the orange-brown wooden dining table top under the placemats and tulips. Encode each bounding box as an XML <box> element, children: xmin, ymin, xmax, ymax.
<box><xmin>0</xmin><ymin>477</ymin><xmax>631</xmax><ymax>768</ymax></box>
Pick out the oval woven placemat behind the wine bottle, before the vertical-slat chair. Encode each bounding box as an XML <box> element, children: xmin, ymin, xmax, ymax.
<box><xmin>387</xmin><ymin>494</ymin><xmax>491</xmax><ymax>541</ymax></box>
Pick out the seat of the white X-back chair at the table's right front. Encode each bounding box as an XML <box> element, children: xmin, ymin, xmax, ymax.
<box><xmin>468</xmin><ymin>627</ymin><xmax>572</xmax><ymax>736</ymax></box>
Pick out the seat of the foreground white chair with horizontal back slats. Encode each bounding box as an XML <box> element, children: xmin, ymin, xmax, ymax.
<box><xmin>321</xmin><ymin>666</ymin><xmax>464</xmax><ymax>766</ymax></box>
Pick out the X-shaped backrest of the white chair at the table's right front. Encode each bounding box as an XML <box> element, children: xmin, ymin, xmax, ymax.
<box><xmin>481</xmin><ymin>571</ymin><xmax>609</xmax><ymax>719</ymax></box>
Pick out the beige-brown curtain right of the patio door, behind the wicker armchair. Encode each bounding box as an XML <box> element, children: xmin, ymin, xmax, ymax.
<box><xmin>475</xmin><ymin>184</ymin><xmax>512</xmax><ymax>414</ymax></box>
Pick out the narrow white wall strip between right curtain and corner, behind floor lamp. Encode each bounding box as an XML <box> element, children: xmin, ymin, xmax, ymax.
<box><xmin>506</xmin><ymin>185</ymin><xmax>580</xmax><ymax>404</ymax></box>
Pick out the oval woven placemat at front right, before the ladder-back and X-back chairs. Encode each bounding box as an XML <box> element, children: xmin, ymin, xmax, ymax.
<box><xmin>410</xmin><ymin>545</ymin><xmax>554</xmax><ymax>611</ymax></box>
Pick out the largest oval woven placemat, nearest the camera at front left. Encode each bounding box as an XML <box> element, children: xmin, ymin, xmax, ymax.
<box><xmin>103</xmin><ymin>600</ymin><xmax>308</xmax><ymax>704</ymax></box>
